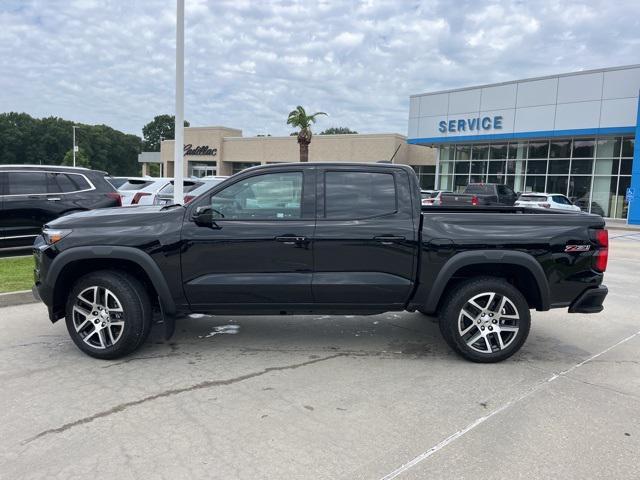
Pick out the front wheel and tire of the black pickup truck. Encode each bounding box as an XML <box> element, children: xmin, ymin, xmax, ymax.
<box><xmin>65</xmin><ymin>270</ymin><xmax>153</xmax><ymax>360</ymax></box>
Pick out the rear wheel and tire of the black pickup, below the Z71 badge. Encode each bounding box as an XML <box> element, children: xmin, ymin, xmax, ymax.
<box><xmin>439</xmin><ymin>277</ymin><xmax>531</xmax><ymax>363</ymax></box>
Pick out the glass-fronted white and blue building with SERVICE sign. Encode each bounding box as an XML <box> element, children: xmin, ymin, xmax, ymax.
<box><xmin>407</xmin><ymin>65</ymin><xmax>640</xmax><ymax>223</ymax></box>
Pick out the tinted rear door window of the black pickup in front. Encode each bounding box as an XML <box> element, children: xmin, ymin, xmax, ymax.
<box><xmin>325</xmin><ymin>172</ymin><xmax>398</xmax><ymax>219</ymax></box>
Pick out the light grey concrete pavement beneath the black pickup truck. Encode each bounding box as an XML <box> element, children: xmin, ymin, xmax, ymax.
<box><xmin>0</xmin><ymin>231</ymin><xmax>640</xmax><ymax>480</ymax></box>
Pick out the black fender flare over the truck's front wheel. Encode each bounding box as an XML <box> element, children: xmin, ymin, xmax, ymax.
<box><xmin>44</xmin><ymin>245</ymin><xmax>176</xmax><ymax>320</ymax></box>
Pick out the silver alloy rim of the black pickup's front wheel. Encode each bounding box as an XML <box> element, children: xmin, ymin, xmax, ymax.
<box><xmin>72</xmin><ymin>286</ymin><xmax>125</xmax><ymax>350</ymax></box>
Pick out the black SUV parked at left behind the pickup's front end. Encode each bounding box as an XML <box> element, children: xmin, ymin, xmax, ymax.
<box><xmin>0</xmin><ymin>165</ymin><xmax>120</xmax><ymax>250</ymax></box>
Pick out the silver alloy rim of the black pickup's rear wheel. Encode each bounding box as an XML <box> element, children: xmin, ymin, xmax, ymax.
<box><xmin>458</xmin><ymin>292</ymin><xmax>520</xmax><ymax>354</ymax></box>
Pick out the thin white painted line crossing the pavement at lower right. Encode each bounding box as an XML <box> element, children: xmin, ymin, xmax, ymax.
<box><xmin>380</xmin><ymin>331</ymin><xmax>640</xmax><ymax>480</ymax></box>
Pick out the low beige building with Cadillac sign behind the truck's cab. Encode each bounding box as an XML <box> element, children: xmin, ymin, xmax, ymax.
<box><xmin>138</xmin><ymin>127</ymin><xmax>436</xmax><ymax>188</ymax></box>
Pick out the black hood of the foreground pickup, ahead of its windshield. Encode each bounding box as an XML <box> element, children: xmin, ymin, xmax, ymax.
<box><xmin>47</xmin><ymin>205</ymin><xmax>185</xmax><ymax>228</ymax></box>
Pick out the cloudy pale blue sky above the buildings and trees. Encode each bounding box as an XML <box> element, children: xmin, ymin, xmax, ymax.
<box><xmin>0</xmin><ymin>0</ymin><xmax>640</xmax><ymax>136</ymax></box>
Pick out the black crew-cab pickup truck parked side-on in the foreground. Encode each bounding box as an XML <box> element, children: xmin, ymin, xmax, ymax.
<box><xmin>34</xmin><ymin>163</ymin><xmax>608</xmax><ymax>362</ymax></box>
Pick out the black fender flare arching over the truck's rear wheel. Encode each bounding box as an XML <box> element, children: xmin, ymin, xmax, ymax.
<box><xmin>422</xmin><ymin>250</ymin><xmax>550</xmax><ymax>313</ymax></box>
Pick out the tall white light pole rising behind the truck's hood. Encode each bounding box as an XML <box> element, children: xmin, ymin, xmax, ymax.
<box><xmin>173</xmin><ymin>0</ymin><xmax>184</xmax><ymax>205</ymax></box>
